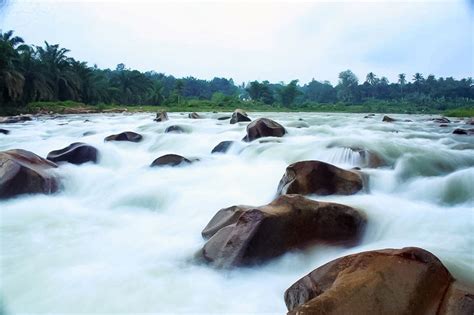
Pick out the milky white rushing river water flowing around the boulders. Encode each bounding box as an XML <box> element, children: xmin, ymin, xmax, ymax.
<box><xmin>0</xmin><ymin>113</ymin><xmax>474</xmax><ymax>314</ymax></box>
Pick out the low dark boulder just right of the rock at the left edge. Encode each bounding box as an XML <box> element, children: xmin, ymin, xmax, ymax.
<box><xmin>46</xmin><ymin>142</ymin><xmax>99</xmax><ymax>165</ymax></box>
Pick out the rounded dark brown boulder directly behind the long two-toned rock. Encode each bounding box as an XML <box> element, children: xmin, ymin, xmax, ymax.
<box><xmin>277</xmin><ymin>161</ymin><xmax>364</xmax><ymax>195</ymax></box>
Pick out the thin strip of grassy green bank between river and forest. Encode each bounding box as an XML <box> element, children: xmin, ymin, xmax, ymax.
<box><xmin>0</xmin><ymin>100</ymin><xmax>474</xmax><ymax>117</ymax></box>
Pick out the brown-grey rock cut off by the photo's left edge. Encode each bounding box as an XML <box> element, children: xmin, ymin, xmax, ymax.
<box><xmin>0</xmin><ymin>149</ymin><xmax>59</xmax><ymax>199</ymax></box>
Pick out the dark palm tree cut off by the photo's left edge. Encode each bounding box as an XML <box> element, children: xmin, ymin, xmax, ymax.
<box><xmin>0</xmin><ymin>31</ymin><xmax>25</xmax><ymax>103</ymax></box>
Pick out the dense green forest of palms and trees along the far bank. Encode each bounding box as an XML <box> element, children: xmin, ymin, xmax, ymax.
<box><xmin>0</xmin><ymin>30</ymin><xmax>474</xmax><ymax>113</ymax></box>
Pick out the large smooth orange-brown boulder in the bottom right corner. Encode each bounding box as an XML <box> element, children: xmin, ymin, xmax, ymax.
<box><xmin>285</xmin><ymin>247</ymin><xmax>474</xmax><ymax>315</ymax></box>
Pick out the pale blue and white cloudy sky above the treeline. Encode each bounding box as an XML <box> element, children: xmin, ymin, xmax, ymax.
<box><xmin>0</xmin><ymin>0</ymin><xmax>474</xmax><ymax>84</ymax></box>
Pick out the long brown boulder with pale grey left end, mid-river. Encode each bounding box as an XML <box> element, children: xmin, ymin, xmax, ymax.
<box><xmin>200</xmin><ymin>195</ymin><xmax>366</xmax><ymax>267</ymax></box>
